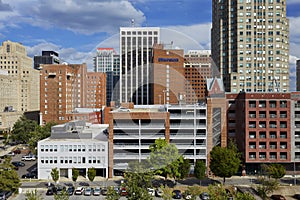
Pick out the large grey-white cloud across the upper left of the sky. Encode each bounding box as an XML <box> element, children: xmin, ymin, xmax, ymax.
<box><xmin>0</xmin><ymin>0</ymin><xmax>145</xmax><ymax>34</ymax></box>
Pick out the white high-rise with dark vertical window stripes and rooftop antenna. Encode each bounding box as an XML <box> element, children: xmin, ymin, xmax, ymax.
<box><xmin>119</xmin><ymin>27</ymin><xmax>160</xmax><ymax>105</ymax></box>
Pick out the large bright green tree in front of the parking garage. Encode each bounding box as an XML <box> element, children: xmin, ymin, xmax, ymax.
<box><xmin>148</xmin><ymin>139</ymin><xmax>183</xmax><ymax>179</ymax></box>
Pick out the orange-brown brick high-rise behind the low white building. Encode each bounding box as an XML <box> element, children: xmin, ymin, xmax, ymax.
<box><xmin>40</xmin><ymin>63</ymin><xmax>106</xmax><ymax>123</ymax></box>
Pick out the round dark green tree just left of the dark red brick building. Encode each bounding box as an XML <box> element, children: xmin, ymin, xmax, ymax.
<box><xmin>210</xmin><ymin>143</ymin><xmax>241</xmax><ymax>183</ymax></box>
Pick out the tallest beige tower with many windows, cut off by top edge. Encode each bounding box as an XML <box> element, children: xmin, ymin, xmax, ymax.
<box><xmin>211</xmin><ymin>0</ymin><xmax>289</xmax><ymax>92</ymax></box>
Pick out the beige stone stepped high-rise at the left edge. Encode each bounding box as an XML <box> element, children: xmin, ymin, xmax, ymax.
<box><xmin>0</xmin><ymin>40</ymin><xmax>40</xmax><ymax>112</ymax></box>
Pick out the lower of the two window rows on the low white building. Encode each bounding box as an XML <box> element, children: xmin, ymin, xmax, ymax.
<box><xmin>41</xmin><ymin>156</ymin><xmax>105</xmax><ymax>164</ymax></box>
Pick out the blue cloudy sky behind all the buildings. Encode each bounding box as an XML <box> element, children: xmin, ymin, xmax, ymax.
<box><xmin>0</xmin><ymin>0</ymin><xmax>300</xmax><ymax>91</ymax></box>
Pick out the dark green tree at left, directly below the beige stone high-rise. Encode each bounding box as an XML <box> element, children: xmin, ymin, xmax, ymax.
<box><xmin>12</xmin><ymin>115</ymin><xmax>38</xmax><ymax>144</ymax></box>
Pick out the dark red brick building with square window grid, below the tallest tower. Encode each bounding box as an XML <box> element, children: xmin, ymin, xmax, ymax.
<box><xmin>226</xmin><ymin>93</ymin><xmax>292</xmax><ymax>172</ymax></box>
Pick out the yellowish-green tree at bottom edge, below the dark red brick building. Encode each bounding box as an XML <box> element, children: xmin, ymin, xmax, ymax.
<box><xmin>256</xmin><ymin>177</ymin><xmax>279</xmax><ymax>200</ymax></box>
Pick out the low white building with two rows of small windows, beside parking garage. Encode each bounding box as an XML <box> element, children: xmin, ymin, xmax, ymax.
<box><xmin>37</xmin><ymin>121</ymin><xmax>108</xmax><ymax>180</ymax></box>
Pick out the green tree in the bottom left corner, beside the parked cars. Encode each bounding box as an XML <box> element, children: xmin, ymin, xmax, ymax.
<box><xmin>0</xmin><ymin>157</ymin><xmax>21</xmax><ymax>192</ymax></box>
